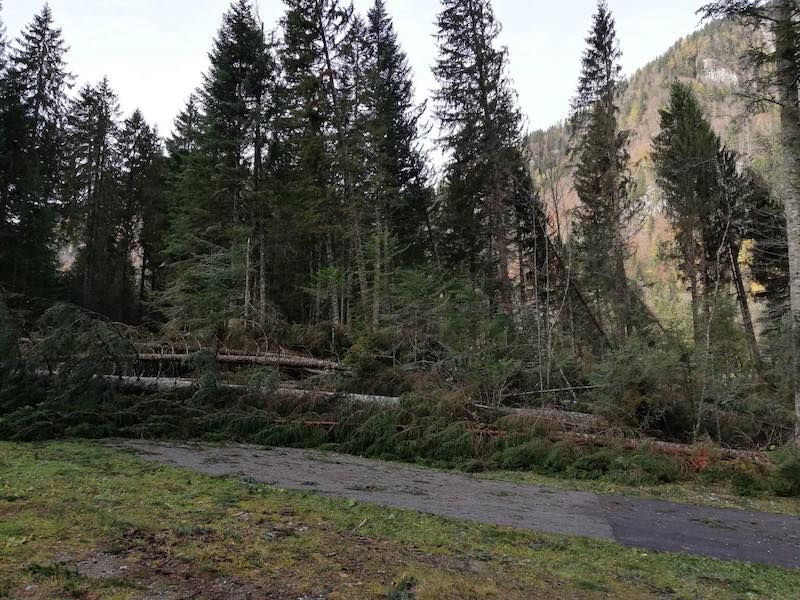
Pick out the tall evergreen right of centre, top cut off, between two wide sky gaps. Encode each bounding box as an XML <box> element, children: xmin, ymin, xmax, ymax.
<box><xmin>434</xmin><ymin>0</ymin><xmax>533</xmax><ymax>313</ymax></box>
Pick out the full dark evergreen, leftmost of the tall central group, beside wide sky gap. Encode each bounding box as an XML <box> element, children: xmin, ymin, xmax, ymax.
<box><xmin>164</xmin><ymin>0</ymin><xmax>274</xmax><ymax>337</ymax></box>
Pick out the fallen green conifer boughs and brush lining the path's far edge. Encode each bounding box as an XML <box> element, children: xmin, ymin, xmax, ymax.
<box><xmin>0</xmin><ymin>306</ymin><xmax>800</xmax><ymax>504</ymax></box>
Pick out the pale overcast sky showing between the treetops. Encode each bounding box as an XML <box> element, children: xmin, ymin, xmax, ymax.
<box><xmin>2</xmin><ymin>0</ymin><xmax>703</xmax><ymax>134</ymax></box>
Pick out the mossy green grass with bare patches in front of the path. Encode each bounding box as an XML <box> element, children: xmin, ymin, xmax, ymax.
<box><xmin>0</xmin><ymin>443</ymin><xmax>800</xmax><ymax>600</ymax></box>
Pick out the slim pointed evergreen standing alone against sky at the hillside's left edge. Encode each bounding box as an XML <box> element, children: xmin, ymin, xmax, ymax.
<box><xmin>570</xmin><ymin>1</ymin><xmax>639</xmax><ymax>340</ymax></box>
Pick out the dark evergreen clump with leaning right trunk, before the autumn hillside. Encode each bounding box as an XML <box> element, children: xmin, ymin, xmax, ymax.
<box><xmin>653</xmin><ymin>82</ymin><xmax>763</xmax><ymax>364</ymax></box>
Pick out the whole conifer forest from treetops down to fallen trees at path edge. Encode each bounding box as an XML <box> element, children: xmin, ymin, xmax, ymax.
<box><xmin>0</xmin><ymin>0</ymin><xmax>800</xmax><ymax>495</ymax></box>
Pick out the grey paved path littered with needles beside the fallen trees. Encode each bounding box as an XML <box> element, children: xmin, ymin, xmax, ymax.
<box><xmin>117</xmin><ymin>441</ymin><xmax>800</xmax><ymax>569</ymax></box>
